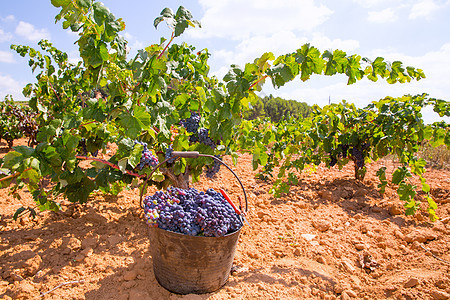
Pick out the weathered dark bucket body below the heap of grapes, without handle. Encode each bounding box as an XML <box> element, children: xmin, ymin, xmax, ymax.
<box><xmin>149</xmin><ymin>227</ymin><xmax>240</xmax><ymax>294</ymax></box>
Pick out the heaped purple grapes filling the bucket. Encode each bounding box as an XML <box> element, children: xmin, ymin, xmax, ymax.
<box><xmin>144</xmin><ymin>187</ymin><xmax>242</xmax><ymax>237</ymax></box>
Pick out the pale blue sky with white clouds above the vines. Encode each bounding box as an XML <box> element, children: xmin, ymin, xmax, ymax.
<box><xmin>0</xmin><ymin>0</ymin><xmax>450</xmax><ymax>122</ymax></box>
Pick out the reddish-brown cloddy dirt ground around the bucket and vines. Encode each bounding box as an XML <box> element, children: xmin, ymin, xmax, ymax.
<box><xmin>0</xmin><ymin>142</ymin><xmax>450</xmax><ymax>300</ymax></box>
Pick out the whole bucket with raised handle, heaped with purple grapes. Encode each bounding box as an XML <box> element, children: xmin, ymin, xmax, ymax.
<box><xmin>141</xmin><ymin>151</ymin><xmax>248</xmax><ymax>294</ymax></box>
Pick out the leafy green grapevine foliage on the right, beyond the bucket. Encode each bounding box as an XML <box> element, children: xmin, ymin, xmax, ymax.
<box><xmin>243</xmin><ymin>94</ymin><xmax>450</xmax><ymax>220</ymax></box>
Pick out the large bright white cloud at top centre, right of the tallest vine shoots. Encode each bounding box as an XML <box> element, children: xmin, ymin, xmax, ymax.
<box><xmin>189</xmin><ymin>0</ymin><xmax>333</xmax><ymax>40</ymax></box>
